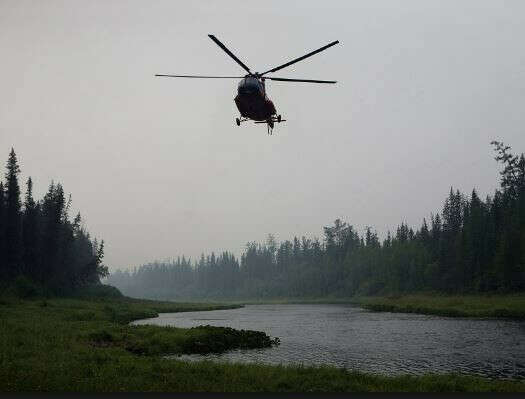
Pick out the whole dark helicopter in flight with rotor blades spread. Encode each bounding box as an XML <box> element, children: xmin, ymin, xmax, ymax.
<box><xmin>155</xmin><ymin>35</ymin><xmax>339</xmax><ymax>135</ymax></box>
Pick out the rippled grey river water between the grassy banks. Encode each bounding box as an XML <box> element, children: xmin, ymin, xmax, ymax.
<box><xmin>134</xmin><ymin>305</ymin><xmax>525</xmax><ymax>378</ymax></box>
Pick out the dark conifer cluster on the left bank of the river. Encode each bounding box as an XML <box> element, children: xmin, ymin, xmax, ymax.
<box><xmin>0</xmin><ymin>149</ymin><xmax>108</xmax><ymax>294</ymax></box>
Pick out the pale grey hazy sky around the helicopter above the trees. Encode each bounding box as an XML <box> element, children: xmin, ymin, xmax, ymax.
<box><xmin>0</xmin><ymin>0</ymin><xmax>525</xmax><ymax>270</ymax></box>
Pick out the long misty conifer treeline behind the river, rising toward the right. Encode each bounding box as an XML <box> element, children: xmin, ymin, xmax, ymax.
<box><xmin>109</xmin><ymin>141</ymin><xmax>525</xmax><ymax>298</ymax></box>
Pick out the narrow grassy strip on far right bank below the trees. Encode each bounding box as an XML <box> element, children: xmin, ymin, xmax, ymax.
<box><xmin>356</xmin><ymin>294</ymin><xmax>525</xmax><ymax>320</ymax></box>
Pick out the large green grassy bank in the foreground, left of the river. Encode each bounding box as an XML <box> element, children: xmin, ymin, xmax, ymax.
<box><xmin>0</xmin><ymin>299</ymin><xmax>525</xmax><ymax>392</ymax></box>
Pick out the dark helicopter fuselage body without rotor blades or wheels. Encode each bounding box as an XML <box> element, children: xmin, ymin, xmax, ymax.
<box><xmin>234</xmin><ymin>76</ymin><xmax>276</xmax><ymax>121</ymax></box>
